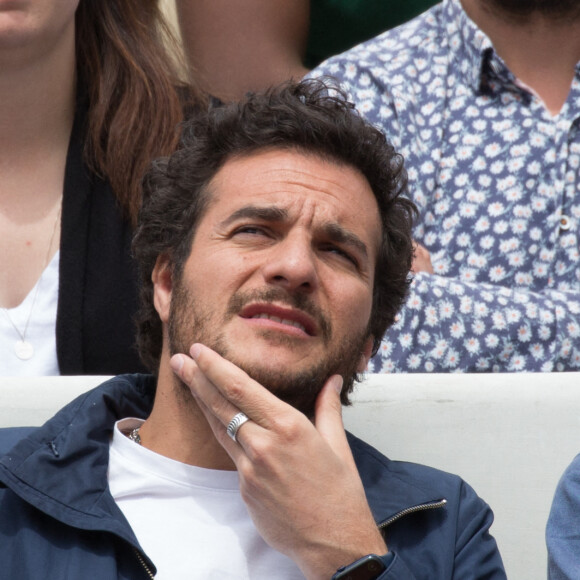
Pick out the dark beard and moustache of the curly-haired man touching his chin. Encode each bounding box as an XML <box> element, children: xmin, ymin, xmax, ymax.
<box><xmin>168</xmin><ymin>281</ymin><xmax>368</xmax><ymax>418</ymax></box>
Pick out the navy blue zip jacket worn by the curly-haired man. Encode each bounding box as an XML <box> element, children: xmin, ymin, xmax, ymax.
<box><xmin>0</xmin><ymin>375</ymin><xmax>505</xmax><ymax>580</ymax></box>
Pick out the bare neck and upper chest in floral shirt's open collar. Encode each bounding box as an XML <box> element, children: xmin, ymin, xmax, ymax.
<box><xmin>461</xmin><ymin>0</ymin><xmax>580</xmax><ymax>114</ymax></box>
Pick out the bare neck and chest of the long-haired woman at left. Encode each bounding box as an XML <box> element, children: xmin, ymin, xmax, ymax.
<box><xmin>0</xmin><ymin>15</ymin><xmax>76</xmax><ymax>308</ymax></box>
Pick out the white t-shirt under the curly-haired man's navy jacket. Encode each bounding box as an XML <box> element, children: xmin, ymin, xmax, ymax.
<box><xmin>109</xmin><ymin>418</ymin><xmax>304</xmax><ymax>580</ymax></box>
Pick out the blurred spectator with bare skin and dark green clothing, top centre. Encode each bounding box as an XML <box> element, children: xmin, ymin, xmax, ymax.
<box><xmin>176</xmin><ymin>0</ymin><xmax>435</xmax><ymax>100</ymax></box>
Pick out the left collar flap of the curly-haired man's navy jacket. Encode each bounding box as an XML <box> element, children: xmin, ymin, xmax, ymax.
<box><xmin>0</xmin><ymin>375</ymin><xmax>155</xmax><ymax>551</ymax></box>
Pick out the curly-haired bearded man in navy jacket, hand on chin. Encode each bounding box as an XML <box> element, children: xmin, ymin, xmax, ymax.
<box><xmin>0</xmin><ymin>81</ymin><xmax>505</xmax><ymax>580</ymax></box>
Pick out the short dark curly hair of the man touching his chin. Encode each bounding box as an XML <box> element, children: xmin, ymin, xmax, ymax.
<box><xmin>133</xmin><ymin>79</ymin><xmax>416</xmax><ymax>372</ymax></box>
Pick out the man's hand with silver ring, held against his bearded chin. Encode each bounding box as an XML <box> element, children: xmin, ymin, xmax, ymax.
<box><xmin>171</xmin><ymin>344</ymin><xmax>387</xmax><ymax>580</ymax></box>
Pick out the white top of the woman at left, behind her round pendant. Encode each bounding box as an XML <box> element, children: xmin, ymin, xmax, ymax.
<box><xmin>0</xmin><ymin>251</ymin><xmax>60</xmax><ymax>377</ymax></box>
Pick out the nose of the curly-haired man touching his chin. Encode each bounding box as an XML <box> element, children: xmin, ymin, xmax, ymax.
<box><xmin>262</xmin><ymin>235</ymin><xmax>318</xmax><ymax>292</ymax></box>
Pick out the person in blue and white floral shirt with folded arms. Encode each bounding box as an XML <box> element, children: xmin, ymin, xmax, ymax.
<box><xmin>311</xmin><ymin>0</ymin><xmax>580</xmax><ymax>372</ymax></box>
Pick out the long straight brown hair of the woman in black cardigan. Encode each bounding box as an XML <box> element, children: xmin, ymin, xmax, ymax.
<box><xmin>75</xmin><ymin>0</ymin><xmax>203</xmax><ymax>224</ymax></box>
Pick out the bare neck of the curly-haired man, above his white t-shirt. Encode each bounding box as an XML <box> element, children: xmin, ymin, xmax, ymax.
<box><xmin>139</xmin><ymin>342</ymin><xmax>235</xmax><ymax>471</ymax></box>
